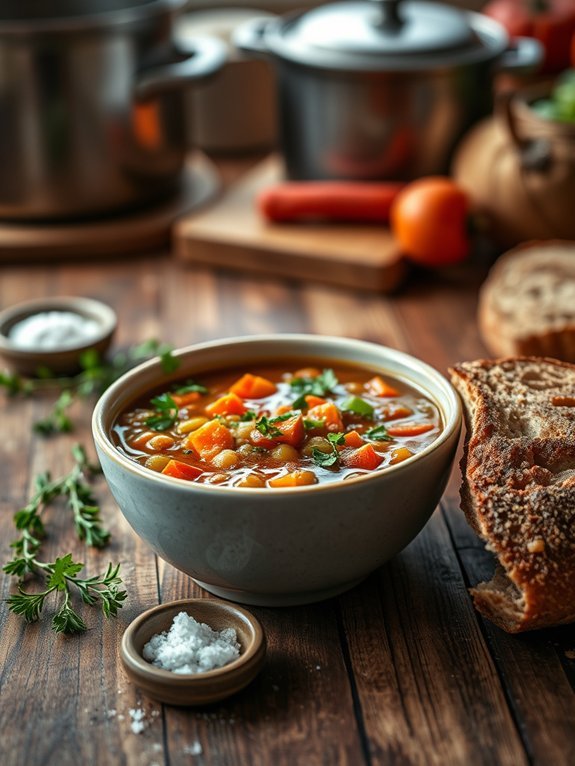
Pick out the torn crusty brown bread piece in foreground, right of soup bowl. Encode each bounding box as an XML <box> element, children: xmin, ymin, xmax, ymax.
<box><xmin>450</xmin><ymin>357</ymin><xmax>575</xmax><ymax>633</ymax></box>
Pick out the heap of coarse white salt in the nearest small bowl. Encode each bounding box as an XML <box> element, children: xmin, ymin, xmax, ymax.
<box><xmin>143</xmin><ymin>612</ymin><xmax>240</xmax><ymax>673</ymax></box>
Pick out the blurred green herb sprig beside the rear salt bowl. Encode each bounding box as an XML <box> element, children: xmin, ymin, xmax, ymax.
<box><xmin>0</xmin><ymin>340</ymin><xmax>179</xmax><ymax>436</ymax></box>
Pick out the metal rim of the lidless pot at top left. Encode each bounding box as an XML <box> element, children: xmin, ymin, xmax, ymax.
<box><xmin>0</xmin><ymin>0</ymin><xmax>187</xmax><ymax>39</ymax></box>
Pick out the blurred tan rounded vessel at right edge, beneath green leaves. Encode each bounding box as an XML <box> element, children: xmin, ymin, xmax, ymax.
<box><xmin>453</xmin><ymin>85</ymin><xmax>575</xmax><ymax>247</ymax></box>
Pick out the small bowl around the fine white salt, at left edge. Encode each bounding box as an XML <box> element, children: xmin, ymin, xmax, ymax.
<box><xmin>0</xmin><ymin>296</ymin><xmax>117</xmax><ymax>376</ymax></box>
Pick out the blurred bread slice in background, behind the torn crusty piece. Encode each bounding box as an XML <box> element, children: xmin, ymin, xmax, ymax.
<box><xmin>477</xmin><ymin>241</ymin><xmax>575</xmax><ymax>362</ymax></box>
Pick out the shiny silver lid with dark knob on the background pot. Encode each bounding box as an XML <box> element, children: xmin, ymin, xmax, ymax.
<box><xmin>266</xmin><ymin>0</ymin><xmax>507</xmax><ymax>69</ymax></box>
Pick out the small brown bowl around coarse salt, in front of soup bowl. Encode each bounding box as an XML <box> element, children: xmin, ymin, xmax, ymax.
<box><xmin>120</xmin><ymin>598</ymin><xmax>266</xmax><ymax>705</ymax></box>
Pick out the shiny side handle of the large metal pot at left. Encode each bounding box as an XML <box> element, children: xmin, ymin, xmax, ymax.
<box><xmin>135</xmin><ymin>37</ymin><xmax>228</xmax><ymax>101</ymax></box>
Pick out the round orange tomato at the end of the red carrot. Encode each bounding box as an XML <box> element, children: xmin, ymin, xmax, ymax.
<box><xmin>390</xmin><ymin>176</ymin><xmax>471</xmax><ymax>266</ymax></box>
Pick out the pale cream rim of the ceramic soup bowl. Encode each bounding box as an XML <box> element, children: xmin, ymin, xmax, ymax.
<box><xmin>92</xmin><ymin>333</ymin><xmax>461</xmax><ymax>499</ymax></box>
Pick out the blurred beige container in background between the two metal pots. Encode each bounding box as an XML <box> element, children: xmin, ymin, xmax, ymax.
<box><xmin>177</xmin><ymin>8</ymin><xmax>277</xmax><ymax>153</ymax></box>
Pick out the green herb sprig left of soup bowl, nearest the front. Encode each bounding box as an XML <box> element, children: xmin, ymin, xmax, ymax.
<box><xmin>3</xmin><ymin>445</ymin><xmax>127</xmax><ymax>633</ymax></box>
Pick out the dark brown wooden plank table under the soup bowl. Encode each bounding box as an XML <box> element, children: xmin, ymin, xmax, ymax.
<box><xmin>0</xmin><ymin>176</ymin><xmax>575</xmax><ymax>766</ymax></box>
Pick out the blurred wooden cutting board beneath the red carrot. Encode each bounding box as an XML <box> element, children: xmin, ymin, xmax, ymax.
<box><xmin>173</xmin><ymin>157</ymin><xmax>406</xmax><ymax>292</ymax></box>
